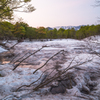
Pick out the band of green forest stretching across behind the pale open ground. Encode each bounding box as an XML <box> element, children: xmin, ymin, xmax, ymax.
<box><xmin>0</xmin><ymin>21</ymin><xmax>100</xmax><ymax>41</ymax></box>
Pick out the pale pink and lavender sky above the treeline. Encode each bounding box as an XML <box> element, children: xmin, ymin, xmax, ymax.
<box><xmin>15</xmin><ymin>0</ymin><xmax>100</xmax><ymax>28</ymax></box>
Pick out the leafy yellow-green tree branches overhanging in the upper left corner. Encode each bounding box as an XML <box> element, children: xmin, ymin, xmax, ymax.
<box><xmin>0</xmin><ymin>0</ymin><xmax>35</xmax><ymax>21</ymax></box>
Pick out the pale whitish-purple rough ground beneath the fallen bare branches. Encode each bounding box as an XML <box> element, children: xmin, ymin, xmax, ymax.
<box><xmin>0</xmin><ymin>39</ymin><xmax>100</xmax><ymax>100</ymax></box>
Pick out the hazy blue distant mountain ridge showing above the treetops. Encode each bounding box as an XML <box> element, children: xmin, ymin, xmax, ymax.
<box><xmin>47</xmin><ymin>25</ymin><xmax>85</xmax><ymax>30</ymax></box>
